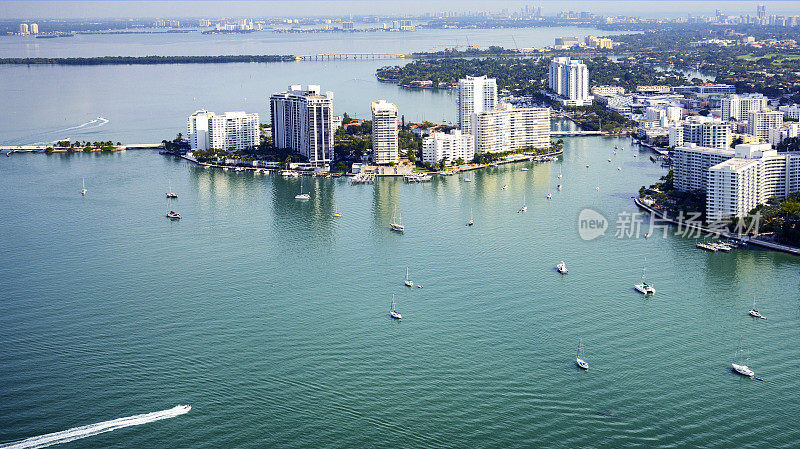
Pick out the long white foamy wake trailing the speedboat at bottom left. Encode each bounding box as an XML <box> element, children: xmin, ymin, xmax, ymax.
<box><xmin>0</xmin><ymin>405</ymin><xmax>192</xmax><ymax>449</ymax></box>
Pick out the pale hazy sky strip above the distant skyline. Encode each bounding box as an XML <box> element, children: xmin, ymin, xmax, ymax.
<box><xmin>0</xmin><ymin>0</ymin><xmax>800</xmax><ymax>19</ymax></box>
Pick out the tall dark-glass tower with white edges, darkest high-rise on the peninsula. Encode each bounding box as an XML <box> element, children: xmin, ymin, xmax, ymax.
<box><xmin>270</xmin><ymin>84</ymin><xmax>336</xmax><ymax>166</ymax></box>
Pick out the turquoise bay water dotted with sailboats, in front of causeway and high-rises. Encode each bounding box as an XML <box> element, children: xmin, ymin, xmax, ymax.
<box><xmin>0</xmin><ymin>137</ymin><xmax>800</xmax><ymax>448</ymax></box>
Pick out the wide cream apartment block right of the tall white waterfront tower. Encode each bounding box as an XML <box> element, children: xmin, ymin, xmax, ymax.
<box><xmin>472</xmin><ymin>103</ymin><xmax>550</xmax><ymax>154</ymax></box>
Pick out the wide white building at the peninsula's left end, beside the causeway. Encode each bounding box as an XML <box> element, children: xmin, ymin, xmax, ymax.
<box><xmin>186</xmin><ymin>110</ymin><xmax>260</xmax><ymax>151</ymax></box>
